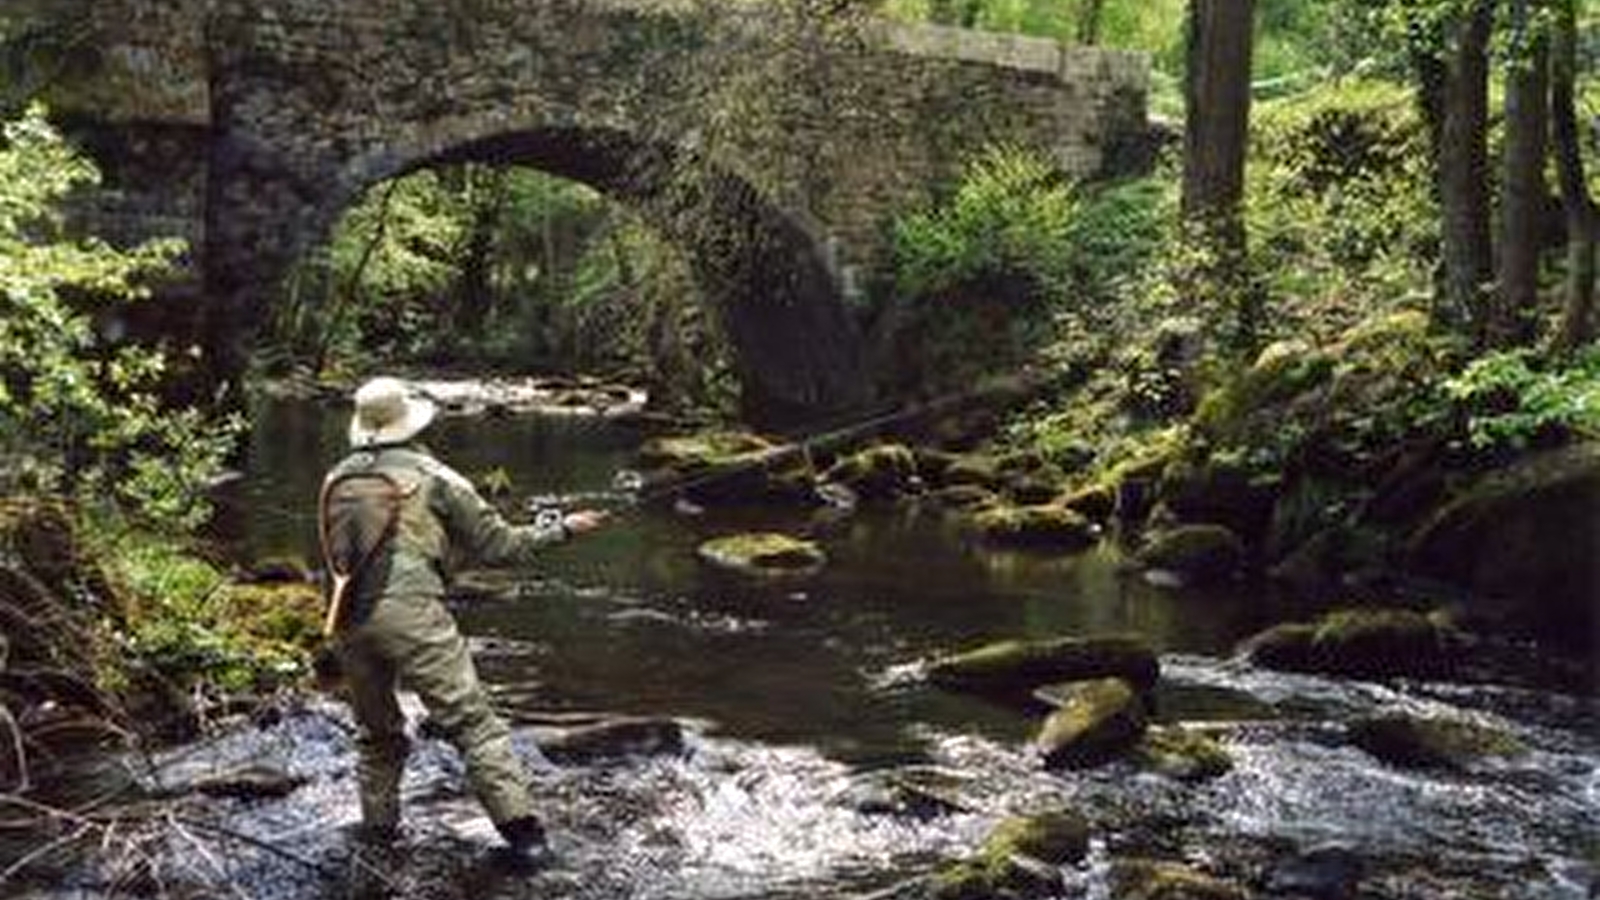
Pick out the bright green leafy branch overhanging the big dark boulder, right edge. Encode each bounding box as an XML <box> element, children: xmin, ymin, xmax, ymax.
<box><xmin>1443</xmin><ymin>348</ymin><xmax>1600</xmax><ymax>450</ymax></box>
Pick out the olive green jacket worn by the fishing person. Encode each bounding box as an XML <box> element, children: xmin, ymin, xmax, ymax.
<box><xmin>328</xmin><ymin>445</ymin><xmax>566</xmax><ymax>609</ymax></box>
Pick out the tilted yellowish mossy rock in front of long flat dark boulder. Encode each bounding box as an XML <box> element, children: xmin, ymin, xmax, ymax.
<box><xmin>1034</xmin><ymin>677</ymin><xmax>1146</xmax><ymax>769</ymax></box>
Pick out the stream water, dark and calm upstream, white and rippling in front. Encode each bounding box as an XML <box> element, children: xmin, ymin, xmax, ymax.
<box><xmin>43</xmin><ymin>395</ymin><xmax>1600</xmax><ymax>900</ymax></box>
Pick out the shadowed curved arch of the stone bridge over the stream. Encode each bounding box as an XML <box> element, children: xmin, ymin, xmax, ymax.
<box><xmin>219</xmin><ymin>114</ymin><xmax>872</xmax><ymax>421</ymax></box>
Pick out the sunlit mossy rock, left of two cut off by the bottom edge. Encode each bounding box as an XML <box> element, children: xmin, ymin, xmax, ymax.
<box><xmin>931</xmin><ymin>810</ymin><xmax>1090</xmax><ymax>900</ymax></box>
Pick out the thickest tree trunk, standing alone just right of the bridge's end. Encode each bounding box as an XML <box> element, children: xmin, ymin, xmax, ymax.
<box><xmin>1182</xmin><ymin>0</ymin><xmax>1259</xmax><ymax>348</ymax></box>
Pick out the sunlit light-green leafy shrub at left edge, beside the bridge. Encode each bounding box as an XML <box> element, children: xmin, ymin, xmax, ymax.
<box><xmin>0</xmin><ymin>107</ymin><xmax>238</xmax><ymax>527</ymax></box>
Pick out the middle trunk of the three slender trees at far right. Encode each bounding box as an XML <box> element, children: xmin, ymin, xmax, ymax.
<box><xmin>1497</xmin><ymin>0</ymin><xmax>1550</xmax><ymax>346</ymax></box>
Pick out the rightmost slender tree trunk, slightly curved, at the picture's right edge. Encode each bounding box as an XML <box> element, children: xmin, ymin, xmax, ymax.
<box><xmin>1550</xmin><ymin>0</ymin><xmax>1595</xmax><ymax>352</ymax></box>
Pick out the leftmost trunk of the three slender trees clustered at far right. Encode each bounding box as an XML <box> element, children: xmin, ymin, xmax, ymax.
<box><xmin>1434</xmin><ymin>0</ymin><xmax>1494</xmax><ymax>327</ymax></box>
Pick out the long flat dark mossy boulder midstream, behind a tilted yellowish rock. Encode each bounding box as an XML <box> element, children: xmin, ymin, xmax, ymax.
<box><xmin>928</xmin><ymin>634</ymin><xmax>1160</xmax><ymax>701</ymax></box>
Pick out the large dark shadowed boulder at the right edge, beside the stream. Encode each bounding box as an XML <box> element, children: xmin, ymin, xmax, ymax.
<box><xmin>1406</xmin><ymin>440</ymin><xmax>1600</xmax><ymax>652</ymax></box>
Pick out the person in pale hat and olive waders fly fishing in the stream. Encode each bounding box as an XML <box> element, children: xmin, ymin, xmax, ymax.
<box><xmin>320</xmin><ymin>378</ymin><xmax>605</xmax><ymax>865</ymax></box>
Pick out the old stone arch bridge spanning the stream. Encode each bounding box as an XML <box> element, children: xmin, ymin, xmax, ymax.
<box><xmin>25</xmin><ymin>0</ymin><xmax>1147</xmax><ymax>415</ymax></box>
